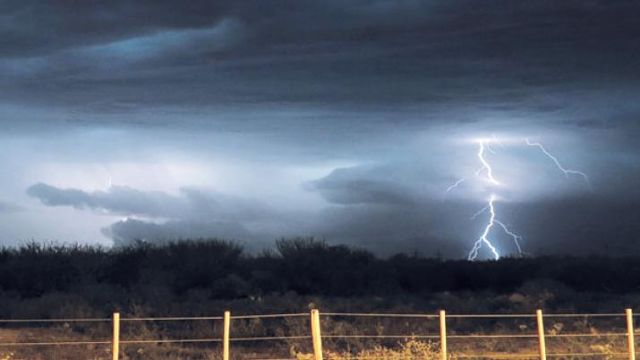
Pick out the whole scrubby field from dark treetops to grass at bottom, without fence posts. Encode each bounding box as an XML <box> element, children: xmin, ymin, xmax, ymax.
<box><xmin>0</xmin><ymin>239</ymin><xmax>640</xmax><ymax>360</ymax></box>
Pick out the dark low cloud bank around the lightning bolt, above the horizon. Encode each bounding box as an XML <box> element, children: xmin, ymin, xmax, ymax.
<box><xmin>307</xmin><ymin>159</ymin><xmax>640</xmax><ymax>258</ymax></box>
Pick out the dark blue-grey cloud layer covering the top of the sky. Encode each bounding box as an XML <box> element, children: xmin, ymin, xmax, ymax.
<box><xmin>5</xmin><ymin>0</ymin><xmax>640</xmax><ymax>116</ymax></box>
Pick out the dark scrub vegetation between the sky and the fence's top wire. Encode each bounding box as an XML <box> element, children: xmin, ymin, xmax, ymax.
<box><xmin>0</xmin><ymin>239</ymin><xmax>640</xmax><ymax>318</ymax></box>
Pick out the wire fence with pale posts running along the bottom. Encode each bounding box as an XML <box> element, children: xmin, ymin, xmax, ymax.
<box><xmin>0</xmin><ymin>309</ymin><xmax>637</xmax><ymax>360</ymax></box>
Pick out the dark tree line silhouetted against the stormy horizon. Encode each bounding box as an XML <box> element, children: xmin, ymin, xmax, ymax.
<box><xmin>0</xmin><ymin>238</ymin><xmax>640</xmax><ymax>299</ymax></box>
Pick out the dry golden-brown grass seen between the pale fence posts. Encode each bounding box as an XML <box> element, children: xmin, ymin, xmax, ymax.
<box><xmin>0</xmin><ymin>313</ymin><xmax>626</xmax><ymax>360</ymax></box>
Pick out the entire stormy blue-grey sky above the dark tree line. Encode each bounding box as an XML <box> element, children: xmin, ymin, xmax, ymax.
<box><xmin>0</xmin><ymin>0</ymin><xmax>640</xmax><ymax>258</ymax></box>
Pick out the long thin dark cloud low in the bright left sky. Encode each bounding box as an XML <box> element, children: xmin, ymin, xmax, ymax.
<box><xmin>27</xmin><ymin>183</ymin><xmax>271</xmax><ymax>221</ymax></box>
